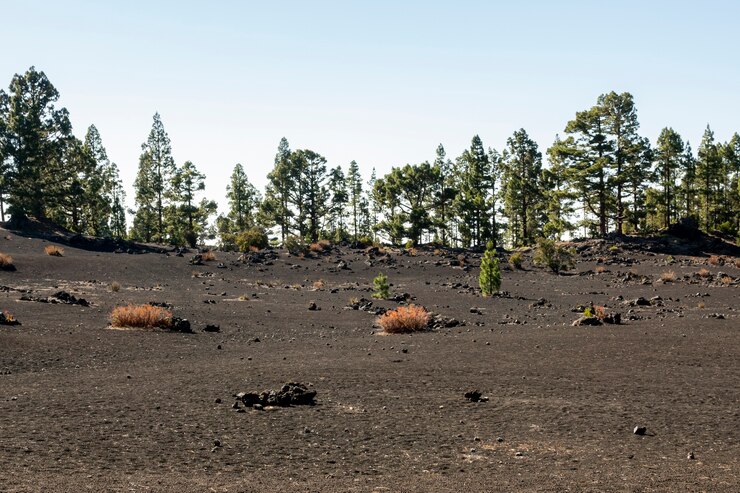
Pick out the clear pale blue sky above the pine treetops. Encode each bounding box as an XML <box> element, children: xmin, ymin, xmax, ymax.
<box><xmin>0</xmin><ymin>0</ymin><xmax>740</xmax><ymax>210</ymax></box>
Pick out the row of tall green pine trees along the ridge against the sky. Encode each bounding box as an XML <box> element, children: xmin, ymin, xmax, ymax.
<box><xmin>0</xmin><ymin>67</ymin><xmax>740</xmax><ymax>248</ymax></box>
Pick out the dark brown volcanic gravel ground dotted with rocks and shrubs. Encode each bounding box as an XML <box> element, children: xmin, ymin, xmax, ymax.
<box><xmin>0</xmin><ymin>231</ymin><xmax>740</xmax><ymax>492</ymax></box>
